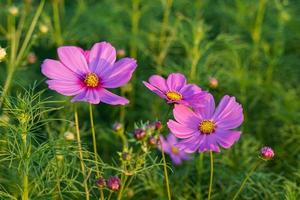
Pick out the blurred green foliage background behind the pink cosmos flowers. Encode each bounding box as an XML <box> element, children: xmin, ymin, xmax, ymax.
<box><xmin>0</xmin><ymin>0</ymin><xmax>300</xmax><ymax>200</ymax></box>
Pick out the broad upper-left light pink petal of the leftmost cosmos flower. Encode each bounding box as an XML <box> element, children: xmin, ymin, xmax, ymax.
<box><xmin>57</xmin><ymin>46</ymin><xmax>90</xmax><ymax>75</ymax></box>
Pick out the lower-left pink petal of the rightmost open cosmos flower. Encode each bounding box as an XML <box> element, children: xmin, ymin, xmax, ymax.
<box><xmin>167</xmin><ymin>120</ymin><xmax>197</xmax><ymax>139</ymax></box>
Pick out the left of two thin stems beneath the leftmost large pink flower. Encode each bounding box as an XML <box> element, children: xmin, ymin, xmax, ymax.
<box><xmin>74</xmin><ymin>107</ymin><xmax>90</xmax><ymax>200</ymax></box>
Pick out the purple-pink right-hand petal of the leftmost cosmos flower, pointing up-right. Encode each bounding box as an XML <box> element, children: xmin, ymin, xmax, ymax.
<box><xmin>101</xmin><ymin>58</ymin><xmax>137</xmax><ymax>88</ymax></box>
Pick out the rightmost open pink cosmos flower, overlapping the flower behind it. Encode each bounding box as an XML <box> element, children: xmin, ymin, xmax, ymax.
<box><xmin>168</xmin><ymin>95</ymin><xmax>244</xmax><ymax>153</ymax></box>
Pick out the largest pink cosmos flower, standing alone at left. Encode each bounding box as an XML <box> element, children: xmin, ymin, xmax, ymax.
<box><xmin>42</xmin><ymin>42</ymin><xmax>137</xmax><ymax>105</ymax></box>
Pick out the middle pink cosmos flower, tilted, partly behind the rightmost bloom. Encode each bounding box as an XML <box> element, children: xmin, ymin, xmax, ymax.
<box><xmin>143</xmin><ymin>73</ymin><xmax>207</xmax><ymax>107</ymax></box>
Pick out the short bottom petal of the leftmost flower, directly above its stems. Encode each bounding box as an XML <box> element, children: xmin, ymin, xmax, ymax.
<box><xmin>71</xmin><ymin>88</ymin><xmax>100</xmax><ymax>104</ymax></box>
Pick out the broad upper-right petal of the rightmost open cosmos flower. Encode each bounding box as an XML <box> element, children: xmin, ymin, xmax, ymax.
<box><xmin>213</xmin><ymin>96</ymin><xmax>244</xmax><ymax>129</ymax></box>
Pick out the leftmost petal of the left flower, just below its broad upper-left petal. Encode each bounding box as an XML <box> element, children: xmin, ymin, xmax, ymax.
<box><xmin>42</xmin><ymin>59</ymin><xmax>79</xmax><ymax>82</ymax></box>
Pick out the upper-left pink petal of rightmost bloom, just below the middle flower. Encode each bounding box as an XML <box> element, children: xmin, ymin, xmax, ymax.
<box><xmin>173</xmin><ymin>104</ymin><xmax>200</xmax><ymax>126</ymax></box>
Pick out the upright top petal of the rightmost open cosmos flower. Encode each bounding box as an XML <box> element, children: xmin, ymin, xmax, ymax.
<box><xmin>195</xmin><ymin>93</ymin><xmax>215</xmax><ymax>119</ymax></box>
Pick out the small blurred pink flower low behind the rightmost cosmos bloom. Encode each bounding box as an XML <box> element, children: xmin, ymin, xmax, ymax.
<box><xmin>160</xmin><ymin>133</ymin><xmax>189</xmax><ymax>165</ymax></box>
